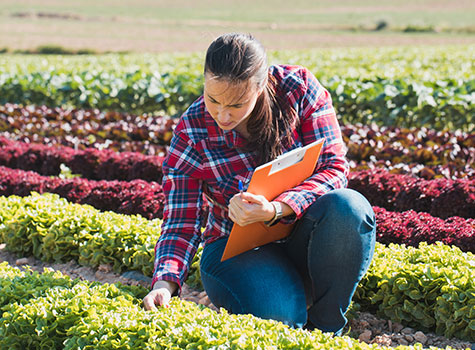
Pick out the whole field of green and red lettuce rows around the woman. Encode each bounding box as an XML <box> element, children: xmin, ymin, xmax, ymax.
<box><xmin>0</xmin><ymin>46</ymin><xmax>475</xmax><ymax>350</ymax></box>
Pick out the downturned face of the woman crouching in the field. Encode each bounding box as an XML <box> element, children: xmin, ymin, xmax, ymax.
<box><xmin>204</xmin><ymin>74</ymin><xmax>262</xmax><ymax>131</ymax></box>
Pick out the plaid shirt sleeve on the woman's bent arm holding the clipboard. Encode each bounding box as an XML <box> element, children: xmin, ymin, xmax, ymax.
<box><xmin>274</xmin><ymin>69</ymin><xmax>349</xmax><ymax>224</ymax></box>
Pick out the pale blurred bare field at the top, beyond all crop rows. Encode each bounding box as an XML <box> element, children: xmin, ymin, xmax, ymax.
<box><xmin>0</xmin><ymin>0</ymin><xmax>475</xmax><ymax>52</ymax></box>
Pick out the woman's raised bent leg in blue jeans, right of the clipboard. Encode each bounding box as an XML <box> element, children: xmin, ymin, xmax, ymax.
<box><xmin>295</xmin><ymin>189</ymin><xmax>376</xmax><ymax>332</ymax></box>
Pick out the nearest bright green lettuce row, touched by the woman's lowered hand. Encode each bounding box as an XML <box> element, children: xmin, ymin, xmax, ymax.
<box><xmin>0</xmin><ymin>263</ymin><xmax>416</xmax><ymax>350</ymax></box>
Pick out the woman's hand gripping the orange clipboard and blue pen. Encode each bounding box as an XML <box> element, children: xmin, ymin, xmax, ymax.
<box><xmin>228</xmin><ymin>192</ymin><xmax>275</xmax><ymax>226</ymax></box>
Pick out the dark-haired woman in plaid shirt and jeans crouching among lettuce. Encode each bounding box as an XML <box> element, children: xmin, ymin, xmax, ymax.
<box><xmin>144</xmin><ymin>34</ymin><xmax>375</xmax><ymax>334</ymax></box>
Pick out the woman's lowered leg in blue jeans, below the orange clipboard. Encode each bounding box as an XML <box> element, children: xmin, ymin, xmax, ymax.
<box><xmin>200</xmin><ymin>239</ymin><xmax>307</xmax><ymax>327</ymax></box>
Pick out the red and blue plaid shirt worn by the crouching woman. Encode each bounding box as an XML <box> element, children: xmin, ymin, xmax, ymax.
<box><xmin>152</xmin><ymin>65</ymin><xmax>348</xmax><ymax>288</ymax></box>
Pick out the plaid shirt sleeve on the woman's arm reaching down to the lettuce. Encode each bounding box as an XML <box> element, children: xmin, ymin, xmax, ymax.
<box><xmin>152</xmin><ymin>133</ymin><xmax>203</xmax><ymax>295</ymax></box>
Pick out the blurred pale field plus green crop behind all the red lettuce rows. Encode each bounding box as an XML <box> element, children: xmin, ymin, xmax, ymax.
<box><xmin>0</xmin><ymin>0</ymin><xmax>475</xmax><ymax>132</ymax></box>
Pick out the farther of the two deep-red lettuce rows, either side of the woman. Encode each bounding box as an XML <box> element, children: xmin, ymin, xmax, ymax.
<box><xmin>0</xmin><ymin>137</ymin><xmax>475</xmax><ymax>218</ymax></box>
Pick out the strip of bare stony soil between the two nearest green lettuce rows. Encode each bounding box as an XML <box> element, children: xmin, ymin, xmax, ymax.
<box><xmin>0</xmin><ymin>244</ymin><xmax>475</xmax><ymax>350</ymax></box>
